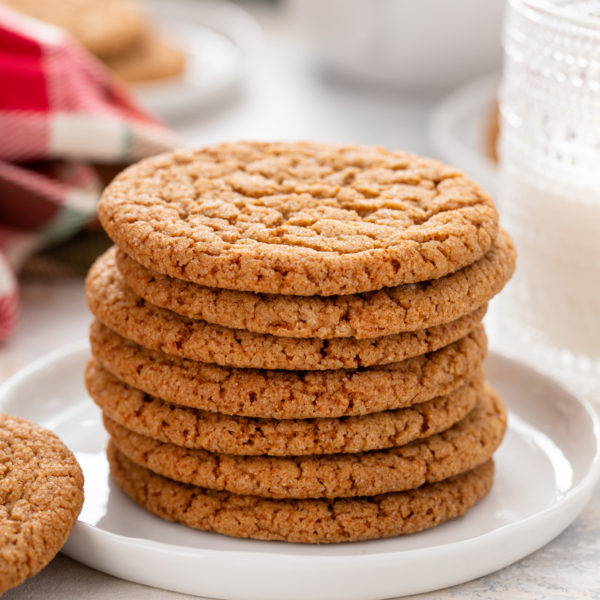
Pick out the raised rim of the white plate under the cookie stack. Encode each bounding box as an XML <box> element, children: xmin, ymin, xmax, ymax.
<box><xmin>0</xmin><ymin>340</ymin><xmax>600</xmax><ymax>570</ymax></box>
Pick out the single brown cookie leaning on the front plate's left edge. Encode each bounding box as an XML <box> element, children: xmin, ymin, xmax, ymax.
<box><xmin>0</xmin><ymin>414</ymin><xmax>83</xmax><ymax>595</ymax></box>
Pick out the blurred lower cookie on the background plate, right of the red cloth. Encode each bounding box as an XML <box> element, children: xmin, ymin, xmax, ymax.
<box><xmin>104</xmin><ymin>27</ymin><xmax>186</xmax><ymax>83</ymax></box>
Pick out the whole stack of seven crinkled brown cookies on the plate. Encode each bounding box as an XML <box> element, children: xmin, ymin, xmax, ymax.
<box><xmin>86</xmin><ymin>143</ymin><xmax>515</xmax><ymax>543</ymax></box>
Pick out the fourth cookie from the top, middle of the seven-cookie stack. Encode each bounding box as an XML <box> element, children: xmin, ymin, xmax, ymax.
<box><xmin>90</xmin><ymin>321</ymin><xmax>487</xmax><ymax>419</ymax></box>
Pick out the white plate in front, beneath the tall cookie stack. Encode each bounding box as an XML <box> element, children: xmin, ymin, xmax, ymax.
<box><xmin>0</xmin><ymin>343</ymin><xmax>600</xmax><ymax>600</ymax></box>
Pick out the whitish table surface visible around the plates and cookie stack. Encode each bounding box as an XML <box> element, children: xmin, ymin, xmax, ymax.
<box><xmin>0</xmin><ymin>5</ymin><xmax>600</xmax><ymax>600</ymax></box>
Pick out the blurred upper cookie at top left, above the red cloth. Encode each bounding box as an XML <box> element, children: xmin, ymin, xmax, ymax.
<box><xmin>2</xmin><ymin>0</ymin><xmax>145</xmax><ymax>58</ymax></box>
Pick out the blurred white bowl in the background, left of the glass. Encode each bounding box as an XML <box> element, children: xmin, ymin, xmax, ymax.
<box><xmin>287</xmin><ymin>0</ymin><xmax>505</xmax><ymax>88</ymax></box>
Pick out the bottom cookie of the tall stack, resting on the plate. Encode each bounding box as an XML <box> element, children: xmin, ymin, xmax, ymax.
<box><xmin>107</xmin><ymin>444</ymin><xmax>494</xmax><ymax>544</ymax></box>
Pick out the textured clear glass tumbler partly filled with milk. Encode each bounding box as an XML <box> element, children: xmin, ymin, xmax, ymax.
<box><xmin>500</xmin><ymin>0</ymin><xmax>600</xmax><ymax>402</ymax></box>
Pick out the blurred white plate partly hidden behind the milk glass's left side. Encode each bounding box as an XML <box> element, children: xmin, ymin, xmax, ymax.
<box><xmin>429</xmin><ymin>73</ymin><xmax>500</xmax><ymax>195</ymax></box>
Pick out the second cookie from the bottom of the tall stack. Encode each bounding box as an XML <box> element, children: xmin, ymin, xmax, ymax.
<box><xmin>104</xmin><ymin>387</ymin><xmax>506</xmax><ymax>498</ymax></box>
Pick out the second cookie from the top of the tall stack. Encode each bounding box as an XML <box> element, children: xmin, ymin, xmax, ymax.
<box><xmin>116</xmin><ymin>230</ymin><xmax>516</xmax><ymax>339</ymax></box>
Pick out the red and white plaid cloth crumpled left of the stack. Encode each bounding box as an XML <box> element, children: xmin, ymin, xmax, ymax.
<box><xmin>0</xmin><ymin>6</ymin><xmax>177</xmax><ymax>341</ymax></box>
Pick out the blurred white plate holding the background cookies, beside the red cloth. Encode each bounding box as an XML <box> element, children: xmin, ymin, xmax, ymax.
<box><xmin>132</xmin><ymin>0</ymin><xmax>262</xmax><ymax>121</ymax></box>
